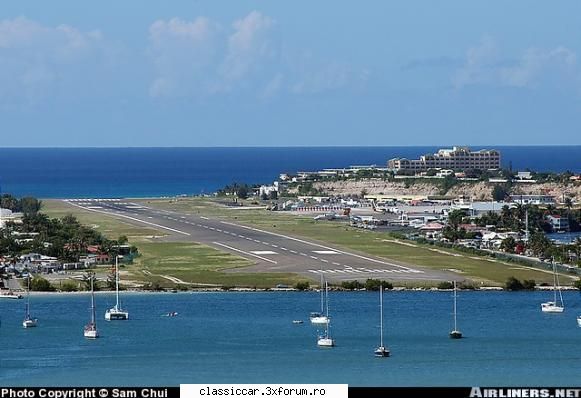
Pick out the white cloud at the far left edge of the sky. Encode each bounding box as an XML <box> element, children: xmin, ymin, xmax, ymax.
<box><xmin>0</xmin><ymin>17</ymin><xmax>111</xmax><ymax>103</ymax></box>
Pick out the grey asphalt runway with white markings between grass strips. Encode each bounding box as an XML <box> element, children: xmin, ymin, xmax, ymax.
<box><xmin>64</xmin><ymin>199</ymin><xmax>458</xmax><ymax>282</ymax></box>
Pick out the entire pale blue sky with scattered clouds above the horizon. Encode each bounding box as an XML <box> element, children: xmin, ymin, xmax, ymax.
<box><xmin>0</xmin><ymin>0</ymin><xmax>581</xmax><ymax>147</ymax></box>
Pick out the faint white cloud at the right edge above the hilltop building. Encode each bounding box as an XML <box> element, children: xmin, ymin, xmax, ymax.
<box><xmin>452</xmin><ymin>37</ymin><xmax>581</xmax><ymax>89</ymax></box>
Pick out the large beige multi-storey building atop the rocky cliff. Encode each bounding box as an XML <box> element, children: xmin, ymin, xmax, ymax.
<box><xmin>387</xmin><ymin>146</ymin><xmax>500</xmax><ymax>171</ymax></box>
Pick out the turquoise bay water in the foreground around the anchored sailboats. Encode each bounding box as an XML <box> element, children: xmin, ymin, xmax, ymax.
<box><xmin>0</xmin><ymin>292</ymin><xmax>581</xmax><ymax>386</ymax></box>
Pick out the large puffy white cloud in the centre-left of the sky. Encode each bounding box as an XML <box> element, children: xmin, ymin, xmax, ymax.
<box><xmin>149</xmin><ymin>11</ymin><xmax>370</xmax><ymax>99</ymax></box>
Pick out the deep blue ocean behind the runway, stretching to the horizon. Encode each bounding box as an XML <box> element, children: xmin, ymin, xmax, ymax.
<box><xmin>0</xmin><ymin>146</ymin><xmax>581</xmax><ymax>198</ymax></box>
